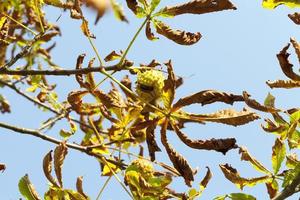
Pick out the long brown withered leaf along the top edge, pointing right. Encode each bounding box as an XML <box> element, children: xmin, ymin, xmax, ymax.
<box><xmin>161</xmin><ymin>0</ymin><xmax>236</xmax><ymax>16</ymax></box>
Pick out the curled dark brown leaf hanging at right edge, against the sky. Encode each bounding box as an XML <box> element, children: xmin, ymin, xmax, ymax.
<box><xmin>277</xmin><ymin>44</ymin><xmax>300</xmax><ymax>81</ymax></box>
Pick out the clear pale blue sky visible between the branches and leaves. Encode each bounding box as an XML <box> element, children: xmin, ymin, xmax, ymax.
<box><xmin>0</xmin><ymin>0</ymin><xmax>300</xmax><ymax>200</ymax></box>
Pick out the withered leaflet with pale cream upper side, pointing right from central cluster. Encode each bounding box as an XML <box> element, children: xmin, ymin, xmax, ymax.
<box><xmin>189</xmin><ymin>108</ymin><xmax>260</xmax><ymax>126</ymax></box>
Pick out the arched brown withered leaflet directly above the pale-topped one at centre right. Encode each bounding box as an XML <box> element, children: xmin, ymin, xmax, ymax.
<box><xmin>173</xmin><ymin>90</ymin><xmax>244</xmax><ymax>110</ymax></box>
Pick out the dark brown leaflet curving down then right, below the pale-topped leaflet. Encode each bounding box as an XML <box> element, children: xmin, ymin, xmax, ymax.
<box><xmin>173</xmin><ymin>125</ymin><xmax>237</xmax><ymax>154</ymax></box>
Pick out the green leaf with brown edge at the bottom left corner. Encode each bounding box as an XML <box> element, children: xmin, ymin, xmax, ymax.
<box><xmin>18</xmin><ymin>174</ymin><xmax>41</xmax><ymax>200</ymax></box>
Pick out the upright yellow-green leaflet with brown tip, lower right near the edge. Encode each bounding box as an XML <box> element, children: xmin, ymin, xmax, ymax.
<box><xmin>272</xmin><ymin>138</ymin><xmax>286</xmax><ymax>174</ymax></box>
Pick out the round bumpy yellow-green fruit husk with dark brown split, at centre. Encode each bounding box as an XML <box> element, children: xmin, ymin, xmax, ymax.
<box><xmin>136</xmin><ymin>70</ymin><xmax>165</xmax><ymax>102</ymax></box>
